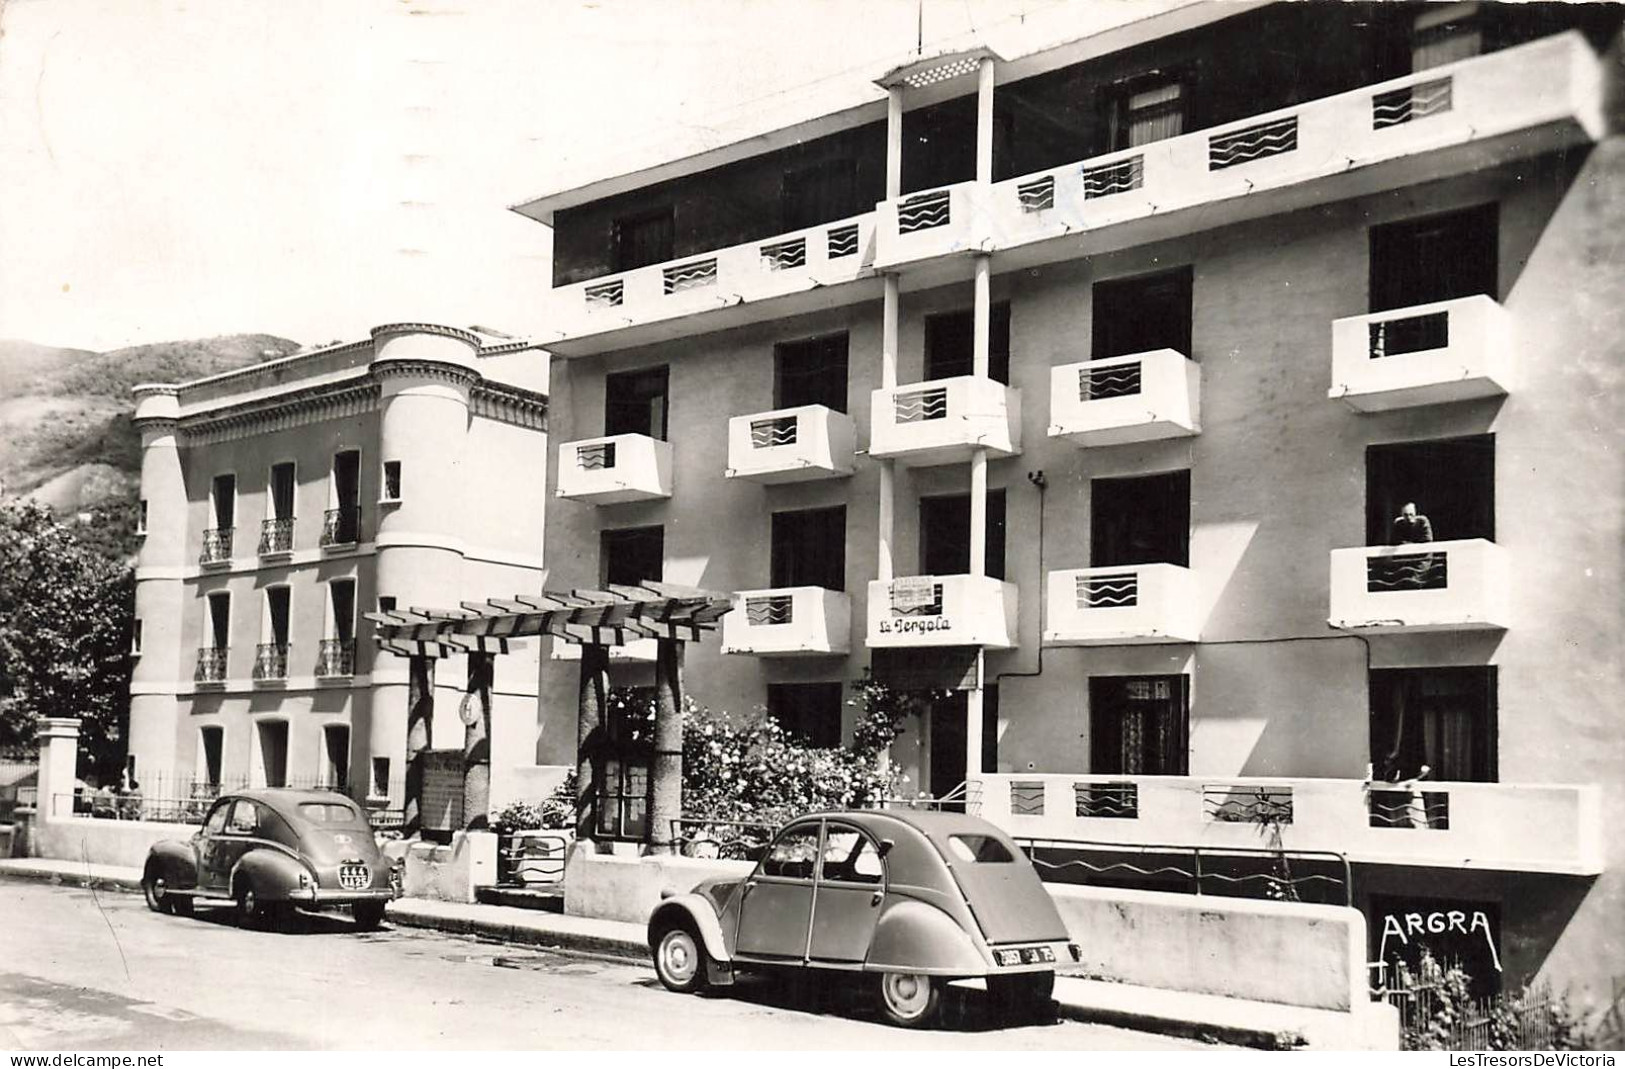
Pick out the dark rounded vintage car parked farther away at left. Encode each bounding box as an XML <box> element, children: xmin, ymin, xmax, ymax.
<box><xmin>141</xmin><ymin>790</ymin><xmax>400</xmax><ymax>929</ymax></box>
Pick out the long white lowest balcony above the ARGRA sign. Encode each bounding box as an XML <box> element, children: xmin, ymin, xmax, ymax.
<box><xmin>970</xmin><ymin>773</ymin><xmax>1602</xmax><ymax>876</ymax></box>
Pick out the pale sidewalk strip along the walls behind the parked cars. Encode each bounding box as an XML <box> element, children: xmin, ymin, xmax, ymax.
<box><xmin>0</xmin><ymin>858</ymin><xmax>1381</xmax><ymax>1050</ymax></box>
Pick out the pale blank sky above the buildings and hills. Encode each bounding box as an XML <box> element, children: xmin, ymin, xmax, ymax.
<box><xmin>0</xmin><ymin>0</ymin><xmax>1121</xmax><ymax>349</ymax></box>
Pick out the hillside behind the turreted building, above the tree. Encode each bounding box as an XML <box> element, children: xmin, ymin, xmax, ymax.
<box><xmin>0</xmin><ymin>335</ymin><xmax>299</xmax><ymax>512</ymax></box>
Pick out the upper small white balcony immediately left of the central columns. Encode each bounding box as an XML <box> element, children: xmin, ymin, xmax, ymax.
<box><xmin>725</xmin><ymin>405</ymin><xmax>856</xmax><ymax>484</ymax></box>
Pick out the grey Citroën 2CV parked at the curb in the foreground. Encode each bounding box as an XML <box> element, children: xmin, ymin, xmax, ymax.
<box><xmin>648</xmin><ymin>811</ymin><xmax>1079</xmax><ymax>1028</ymax></box>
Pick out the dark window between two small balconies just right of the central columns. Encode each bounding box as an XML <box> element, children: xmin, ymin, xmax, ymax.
<box><xmin>1089</xmin><ymin>471</ymin><xmax>1191</xmax><ymax>569</ymax></box>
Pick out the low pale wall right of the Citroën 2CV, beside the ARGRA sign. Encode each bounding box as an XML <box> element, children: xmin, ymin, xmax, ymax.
<box><xmin>1048</xmin><ymin>884</ymin><xmax>1370</xmax><ymax>1014</ymax></box>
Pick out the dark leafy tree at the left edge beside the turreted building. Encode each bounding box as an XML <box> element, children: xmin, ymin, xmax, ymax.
<box><xmin>0</xmin><ymin>497</ymin><xmax>135</xmax><ymax>775</ymax></box>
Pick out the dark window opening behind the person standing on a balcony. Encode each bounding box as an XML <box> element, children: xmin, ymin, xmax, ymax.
<box><xmin>1365</xmin><ymin>434</ymin><xmax>1495</xmax><ymax>546</ymax></box>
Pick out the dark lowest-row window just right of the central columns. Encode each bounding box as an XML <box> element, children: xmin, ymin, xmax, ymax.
<box><xmin>1089</xmin><ymin>676</ymin><xmax>1191</xmax><ymax>777</ymax></box>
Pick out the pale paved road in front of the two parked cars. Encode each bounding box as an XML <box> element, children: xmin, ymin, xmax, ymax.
<box><xmin>0</xmin><ymin>881</ymin><xmax>1222</xmax><ymax>1050</ymax></box>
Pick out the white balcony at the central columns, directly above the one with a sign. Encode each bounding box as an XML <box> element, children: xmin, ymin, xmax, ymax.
<box><xmin>869</xmin><ymin>375</ymin><xmax>1021</xmax><ymax>466</ymax></box>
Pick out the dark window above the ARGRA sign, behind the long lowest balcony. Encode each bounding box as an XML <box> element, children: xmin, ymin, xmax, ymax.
<box><xmin>1372</xmin><ymin>666</ymin><xmax>1497</xmax><ymax>783</ymax></box>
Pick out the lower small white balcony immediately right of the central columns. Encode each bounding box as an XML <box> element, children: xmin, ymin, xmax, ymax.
<box><xmin>1043</xmin><ymin>564</ymin><xmax>1201</xmax><ymax>647</ymax></box>
